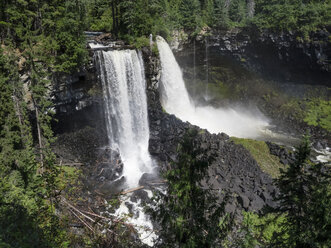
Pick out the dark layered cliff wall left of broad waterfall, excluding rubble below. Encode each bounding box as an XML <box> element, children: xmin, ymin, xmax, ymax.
<box><xmin>52</xmin><ymin>56</ymin><xmax>104</xmax><ymax>134</ymax></box>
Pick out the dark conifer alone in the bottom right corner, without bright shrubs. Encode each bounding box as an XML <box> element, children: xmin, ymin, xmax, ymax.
<box><xmin>274</xmin><ymin>137</ymin><xmax>331</xmax><ymax>247</ymax></box>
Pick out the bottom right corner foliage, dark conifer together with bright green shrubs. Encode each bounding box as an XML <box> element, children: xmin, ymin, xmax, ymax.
<box><xmin>234</xmin><ymin>137</ymin><xmax>331</xmax><ymax>248</ymax></box>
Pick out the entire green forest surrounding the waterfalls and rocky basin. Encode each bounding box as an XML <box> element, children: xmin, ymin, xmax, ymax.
<box><xmin>0</xmin><ymin>0</ymin><xmax>331</xmax><ymax>248</ymax></box>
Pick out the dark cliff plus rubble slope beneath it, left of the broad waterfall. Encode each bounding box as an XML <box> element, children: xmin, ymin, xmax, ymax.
<box><xmin>52</xmin><ymin>52</ymin><xmax>107</xmax><ymax>164</ymax></box>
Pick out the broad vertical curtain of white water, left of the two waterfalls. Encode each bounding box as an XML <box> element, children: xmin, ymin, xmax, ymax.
<box><xmin>96</xmin><ymin>50</ymin><xmax>152</xmax><ymax>187</ymax></box>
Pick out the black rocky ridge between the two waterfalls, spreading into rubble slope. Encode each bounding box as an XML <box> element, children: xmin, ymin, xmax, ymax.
<box><xmin>143</xmin><ymin>50</ymin><xmax>278</xmax><ymax>213</ymax></box>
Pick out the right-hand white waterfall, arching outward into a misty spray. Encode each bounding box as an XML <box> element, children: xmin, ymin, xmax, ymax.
<box><xmin>157</xmin><ymin>37</ymin><xmax>268</xmax><ymax>138</ymax></box>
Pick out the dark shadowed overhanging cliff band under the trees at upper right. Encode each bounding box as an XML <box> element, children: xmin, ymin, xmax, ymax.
<box><xmin>204</xmin><ymin>29</ymin><xmax>331</xmax><ymax>85</ymax></box>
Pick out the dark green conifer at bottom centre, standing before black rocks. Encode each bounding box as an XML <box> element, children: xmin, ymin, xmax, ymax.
<box><xmin>152</xmin><ymin>130</ymin><xmax>231</xmax><ymax>247</ymax></box>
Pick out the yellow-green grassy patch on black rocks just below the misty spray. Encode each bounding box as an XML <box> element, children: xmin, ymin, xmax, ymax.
<box><xmin>231</xmin><ymin>137</ymin><xmax>285</xmax><ymax>178</ymax></box>
